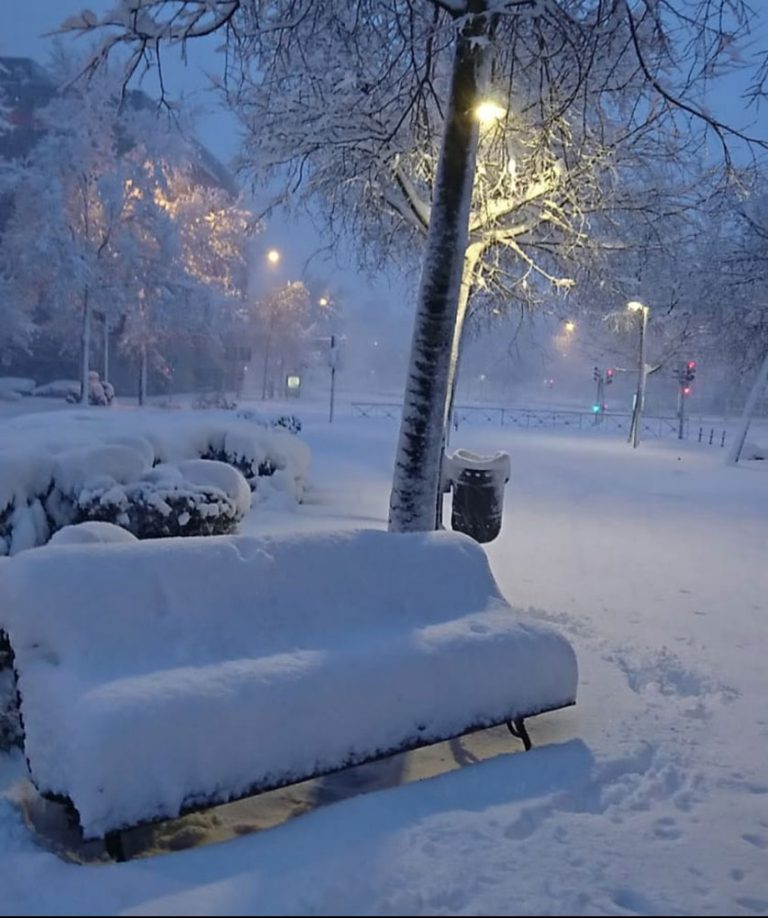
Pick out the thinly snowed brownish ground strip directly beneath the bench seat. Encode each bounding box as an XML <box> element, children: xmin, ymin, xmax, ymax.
<box><xmin>14</xmin><ymin>711</ymin><xmax>565</xmax><ymax>864</ymax></box>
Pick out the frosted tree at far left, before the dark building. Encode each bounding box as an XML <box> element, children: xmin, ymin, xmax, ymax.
<box><xmin>2</xmin><ymin>72</ymin><xmax>146</xmax><ymax>400</ymax></box>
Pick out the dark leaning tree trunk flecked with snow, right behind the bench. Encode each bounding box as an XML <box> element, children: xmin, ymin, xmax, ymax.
<box><xmin>389</xmin><ymin>2</ymin><xmax>490</xmax><ymax>532</ymax></box>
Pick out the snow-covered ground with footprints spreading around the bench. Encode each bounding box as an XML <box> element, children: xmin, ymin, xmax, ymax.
<box><xmin>0</xmin><ymin>400</ymin><xmax>768</xmax><ymax>915</ymax></box>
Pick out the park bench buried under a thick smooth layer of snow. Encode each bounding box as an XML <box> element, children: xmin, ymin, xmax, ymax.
<box><xmin>0</xmin><ymin>530</ymin><xmax>577</xmax><ymax>857</ymax></box>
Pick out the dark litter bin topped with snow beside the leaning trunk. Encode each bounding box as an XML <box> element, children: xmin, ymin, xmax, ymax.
<box><xmin>446</xmin><ymin>449</ymin><xmax>509</xmax><ymax>542</ymax></box>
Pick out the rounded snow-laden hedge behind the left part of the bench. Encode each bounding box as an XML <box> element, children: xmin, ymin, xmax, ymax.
<box><xmin>0</xmin><ymin>409</ymin><xmax>310</xmax><ymax>555</ymax></box>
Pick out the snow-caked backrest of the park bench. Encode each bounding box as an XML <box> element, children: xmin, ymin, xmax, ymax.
<box><xmin>0</xmin><ymin>530</ymin><xmax>503</xmax><ymax>682</ymax></box>
